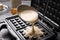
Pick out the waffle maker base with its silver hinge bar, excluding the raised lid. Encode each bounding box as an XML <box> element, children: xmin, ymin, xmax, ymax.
<box><xmin>1</xmin><ymin>1</ymin><xmax>59</xmax><ymax>40</ymax></box>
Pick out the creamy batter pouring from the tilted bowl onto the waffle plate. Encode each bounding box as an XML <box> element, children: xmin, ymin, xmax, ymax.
<box><xmin>19</xmin><ymin>10</ymin><xmax>43</xmax><ymax>40</ymax></box>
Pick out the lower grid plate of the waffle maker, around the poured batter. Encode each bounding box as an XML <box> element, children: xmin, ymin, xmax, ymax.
<box><xmin>6</xmin><ymin>15</ymin><xmax>57</xmax><ymax>40</ymax></box>
